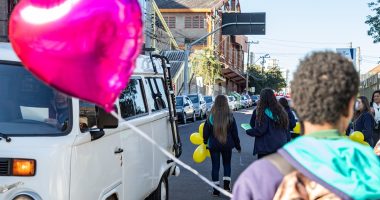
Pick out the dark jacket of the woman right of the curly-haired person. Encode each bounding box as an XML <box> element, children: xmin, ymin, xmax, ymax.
<box><xmin>353</xmin><ymin>112</ymin><xmax>375</xmax><ymax>146</ymax></box>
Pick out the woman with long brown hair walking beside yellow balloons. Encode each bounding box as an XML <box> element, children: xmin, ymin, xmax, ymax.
<box><xmin>203</xmin><ymin>95</ymin><xmax>241</xmax><ymax>196</ymax></box>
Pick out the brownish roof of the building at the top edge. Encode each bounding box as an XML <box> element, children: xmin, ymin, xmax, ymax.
<box><xmin>156</xmin><ymin>0</ymin><xmax>225</xmax><ymax>9</ymax></box>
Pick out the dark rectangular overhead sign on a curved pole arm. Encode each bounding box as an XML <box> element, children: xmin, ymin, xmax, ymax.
<box><xmin>222</xmin><ymin>13</ymin><xmax>265</xmax><ymax>35</ymax></box>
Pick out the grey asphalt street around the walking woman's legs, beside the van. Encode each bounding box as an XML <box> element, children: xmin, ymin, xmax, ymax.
<box><xmin>169</xmin><ymin>108</ymin><xmax>255</xmax><ymax>200</ymax></box>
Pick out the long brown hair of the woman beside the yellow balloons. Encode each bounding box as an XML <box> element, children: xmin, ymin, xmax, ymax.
<box><xmin>211</xmin><ymin>95</ymin><xmax>232</xmax><ymax>144</ymax></box>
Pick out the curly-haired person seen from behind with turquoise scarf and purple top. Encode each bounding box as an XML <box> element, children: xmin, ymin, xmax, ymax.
<box><xmin>232</xmin><ymin>52</ymin><xmax>380</xmax><ymax>200</ymax></box>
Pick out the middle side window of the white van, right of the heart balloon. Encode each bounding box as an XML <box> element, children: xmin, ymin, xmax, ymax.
<box><xmin>119</xmin><ymin>79</ymin><xmax>147</xmax><ymax>118</ymax></box>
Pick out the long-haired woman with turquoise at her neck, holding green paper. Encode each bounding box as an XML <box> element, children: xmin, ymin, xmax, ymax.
<box><xmin>246</xmin><ymin>88</ymin><xmax>289</xmax><ymax>159</ymax></box>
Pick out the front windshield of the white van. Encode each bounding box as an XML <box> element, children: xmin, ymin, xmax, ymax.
<box><xmin>0</xmin><ymin>63</ymin><xmax>72</xmax><ymax>136</ymax></box>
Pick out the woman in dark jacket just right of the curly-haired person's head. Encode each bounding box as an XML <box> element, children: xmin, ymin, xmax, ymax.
<box><xmin>352</xmin><ymin>96</ymin><xmax>375</xmax><ymax>147</ymax></box>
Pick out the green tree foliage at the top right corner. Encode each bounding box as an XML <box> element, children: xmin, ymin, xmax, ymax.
<box><xmin>365</xmin><ymin>0</ymin><xmax>380</xmax><ymax>43</ymax></box>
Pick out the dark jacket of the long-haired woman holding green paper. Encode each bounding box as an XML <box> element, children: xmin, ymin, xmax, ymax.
<box><xmin>246</xmin><ymin>110</ymin><xmax>288</xmax><ymax>155</ymax></box>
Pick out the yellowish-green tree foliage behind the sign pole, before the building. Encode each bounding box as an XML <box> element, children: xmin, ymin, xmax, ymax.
<box><xmin>190</xmin><ymin>48</ymin><xmax>222</xmax><ymax>86</ymax></box>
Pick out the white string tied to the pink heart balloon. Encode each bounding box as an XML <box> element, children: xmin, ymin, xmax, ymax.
<box><xmin>111</xmin><ymin>111</ymin><xmax>232</xmax><ymax>198</ymax></box>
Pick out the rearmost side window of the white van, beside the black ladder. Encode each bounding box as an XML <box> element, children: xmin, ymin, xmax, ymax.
<box><xmin>145</xmin><ymin>78</ymin><xmax>168</xmax><ymax>112</ymax></box>
